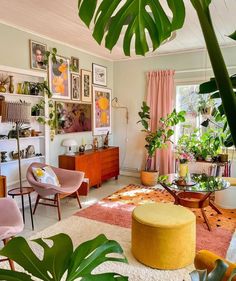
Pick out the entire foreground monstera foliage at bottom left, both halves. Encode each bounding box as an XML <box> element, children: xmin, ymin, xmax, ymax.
<box><xmin>0</xmin><ymin>233</ymin><xmax>128</xmax><ymax>281</ymax></box>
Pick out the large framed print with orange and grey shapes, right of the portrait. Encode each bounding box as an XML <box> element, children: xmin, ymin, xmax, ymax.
<box><xmin>49</xmin><ymin>56</ymin><xmax>71</xmax><ymax>99</ymax></box>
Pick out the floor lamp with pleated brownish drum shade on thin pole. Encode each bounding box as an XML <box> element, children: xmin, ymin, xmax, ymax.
<box><xmin>0</xmin><ymin>101</ymin><xmax>31</xmax><ymax>221</ymax></box>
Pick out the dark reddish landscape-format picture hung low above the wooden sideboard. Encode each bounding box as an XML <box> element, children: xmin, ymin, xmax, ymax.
<box><xmin>56</xmin><ymin>102</ymin><xmax>92</xmax><ymax>134</ymax></box>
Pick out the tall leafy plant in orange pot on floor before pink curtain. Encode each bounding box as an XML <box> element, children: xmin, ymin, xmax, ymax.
<box><xmin>137</xmin><ymin>102</ymin><xmax>185</xmax><ymax>186</ymax></box>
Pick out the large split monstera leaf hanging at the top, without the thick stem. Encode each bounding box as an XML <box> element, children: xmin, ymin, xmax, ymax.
<box><xmin>79</xmin><ymin>0</ymin><xmax>185</xmax><ymax>56</ymax></box>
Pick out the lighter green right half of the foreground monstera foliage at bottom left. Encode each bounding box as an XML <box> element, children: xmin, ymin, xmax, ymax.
<box><xmin>66</xmin><ymin>234</ymin><xmax>127</xmax><ymax>281</ymax></box>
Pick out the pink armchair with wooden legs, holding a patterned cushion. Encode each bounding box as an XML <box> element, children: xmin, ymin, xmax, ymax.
<box><xmin>26</xmin><ymin>163</ymin><xmax>84</xmax><ymax>220</ymax></box>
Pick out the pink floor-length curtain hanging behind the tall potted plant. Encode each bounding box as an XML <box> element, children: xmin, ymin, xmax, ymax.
<box><xmin>147</xmin><ymin>70</ymin><xmax>175</xmax><ymax>175</ymax></box>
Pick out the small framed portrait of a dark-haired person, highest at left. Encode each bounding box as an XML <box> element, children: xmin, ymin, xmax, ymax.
<box><xmin>30</xmin><ymin>40</ymin><xmax>47</xmax><ymax>71</ymax></box>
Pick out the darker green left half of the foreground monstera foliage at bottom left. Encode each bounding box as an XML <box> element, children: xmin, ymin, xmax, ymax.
<box><xmin>0</xmin><ymin>233</ymin><xmax>73</xmax><ymax>281</ymax></box>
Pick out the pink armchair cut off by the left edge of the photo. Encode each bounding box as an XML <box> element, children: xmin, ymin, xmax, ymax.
<box><xmin>0</xmin><ymin>198</ymin><xmax>24</xmax><ymax>270</ymax></box>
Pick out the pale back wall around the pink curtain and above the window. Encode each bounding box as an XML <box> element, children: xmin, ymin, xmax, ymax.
<box><xmin>113</xmin><ymin>47</ymin><xmax>236</xmax><ymax>173</ymax></box>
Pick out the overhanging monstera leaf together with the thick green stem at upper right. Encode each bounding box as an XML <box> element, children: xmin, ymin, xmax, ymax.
<box><xmin>78</xmin><ymin>0</ymin><xmax>236</xmax><ymax>144</ymax></box>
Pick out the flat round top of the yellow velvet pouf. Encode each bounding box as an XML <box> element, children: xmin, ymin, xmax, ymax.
<box><xmin>132</xmin><ymin>203</ymin><xmax>196</xmax><ymax>228</ymax></box>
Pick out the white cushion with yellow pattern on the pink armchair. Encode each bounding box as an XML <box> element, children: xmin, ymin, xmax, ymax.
<box><xmin>32</xmin><ymin>166</ymin><xmax>61</xmax><ymax>187</ymax></box>
